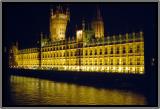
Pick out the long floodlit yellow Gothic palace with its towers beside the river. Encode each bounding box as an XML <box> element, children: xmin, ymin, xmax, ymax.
<box><xmin>9</xmin><ymin>6</ymin><xmax>144</xmax><ymax>74</ymax></box>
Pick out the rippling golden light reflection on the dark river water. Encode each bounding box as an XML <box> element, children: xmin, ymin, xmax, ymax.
<box><xmin>10</xmin><ymin>76</ymin><xmax>146</xmax><ymax>105</ymax></box>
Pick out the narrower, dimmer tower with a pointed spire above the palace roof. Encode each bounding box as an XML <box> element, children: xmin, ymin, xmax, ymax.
<box><xmin>91</xmin><ymin>7</ymin><xmax>104</xmax><ymax>38</ymax></box>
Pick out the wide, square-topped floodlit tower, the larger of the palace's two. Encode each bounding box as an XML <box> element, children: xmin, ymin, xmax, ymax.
<box><xmin>50</xmin><ymin>6</ymin><xmax>70</xmax><ymax>41</ymax></box>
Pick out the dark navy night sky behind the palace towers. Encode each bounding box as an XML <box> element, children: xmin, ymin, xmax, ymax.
<box><xmin>3</xmin><ymin>3</ymin><xmax>157</xmax><ymax>54</ymax></box>
